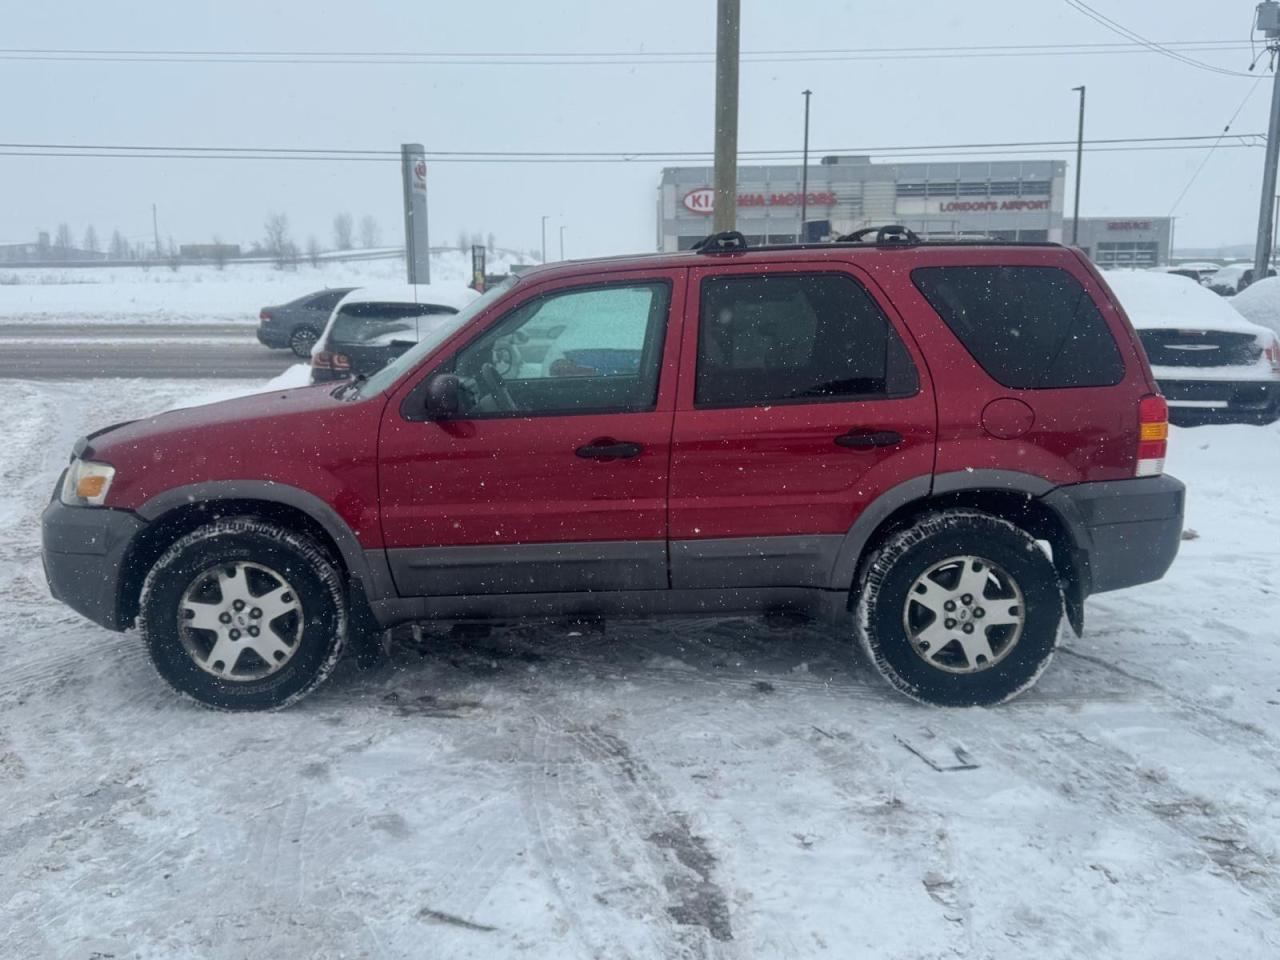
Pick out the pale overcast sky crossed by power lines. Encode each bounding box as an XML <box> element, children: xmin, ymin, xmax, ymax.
<box><xmin>0</xmin><ymin>0</ymin><xmax>1270</xmax><ymax>256</ymax></box>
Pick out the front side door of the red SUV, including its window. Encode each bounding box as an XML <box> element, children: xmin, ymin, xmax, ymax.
<box><xmin>379</xmin><ymin>270</ymin><xmax>685</xmax><ymax>596</ymax></box>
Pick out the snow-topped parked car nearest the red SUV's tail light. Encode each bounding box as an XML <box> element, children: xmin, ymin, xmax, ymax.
<box><xmin>1106</xmin><ymin>270</ymin><xmax>1280</xmax><ymax>426</ymax></box>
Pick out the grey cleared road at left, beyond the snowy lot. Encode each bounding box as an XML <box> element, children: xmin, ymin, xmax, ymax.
<box><xmin>0</xmin><ymin>324</ymin><xmax>298</xmax><ymax>380</ymax></box>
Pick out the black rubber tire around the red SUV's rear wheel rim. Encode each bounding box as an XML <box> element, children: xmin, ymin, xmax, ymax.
<box><xmin>855</xmin><ymin>509</ymin><xmax>1062</xmax><ymax>707</ymax></box>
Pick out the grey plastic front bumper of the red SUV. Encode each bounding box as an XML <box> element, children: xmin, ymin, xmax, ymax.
<box><xmin>41</xmin><ymin>484</ymin><xmax>146</xmax><ymax>630</ymax></box>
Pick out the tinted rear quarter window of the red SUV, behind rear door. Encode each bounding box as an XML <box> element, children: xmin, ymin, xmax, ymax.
<box><xmin>911</xmin><ymin>266</ymin><xmax>1124</xmax><ymax>390</ymax></box>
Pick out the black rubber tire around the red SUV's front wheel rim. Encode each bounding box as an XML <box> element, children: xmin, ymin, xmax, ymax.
<box><xmin>138</xmin><ymin>517</ymin><xmax>347</xmax><ymax>710</ymax></box>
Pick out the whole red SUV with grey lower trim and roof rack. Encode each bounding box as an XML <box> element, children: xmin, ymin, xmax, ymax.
<box><xmin>44</xmin><ymin>232</ymin><xmax>1184</xmax><ymax>709</ymax></box>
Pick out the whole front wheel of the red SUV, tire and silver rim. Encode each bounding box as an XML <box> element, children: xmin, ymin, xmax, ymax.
<box><xmin>138</xmin><ymin>517</ymin><xmax>347</xmax><ymax>710</ymax></box>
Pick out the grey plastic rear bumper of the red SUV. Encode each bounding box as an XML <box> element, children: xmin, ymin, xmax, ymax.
<box><xmin>1044</xmin><ymin>476</ymin><xmax>1187</xmax><ymax>595</ymax></box>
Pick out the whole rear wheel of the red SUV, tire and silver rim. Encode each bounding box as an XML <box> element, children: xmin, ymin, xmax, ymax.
<box><xmin>855</xmin><ymin>511</ymin><xmax>1062</xmax><ymax>707</ymax></box>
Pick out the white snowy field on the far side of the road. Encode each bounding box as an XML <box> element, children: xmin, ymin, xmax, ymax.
<box><xmin>0</xmin><ymin>251</ymin><xmax>513</xmax><ymax>325</ymax></box>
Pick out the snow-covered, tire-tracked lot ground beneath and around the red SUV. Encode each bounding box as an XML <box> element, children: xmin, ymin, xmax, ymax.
<box><xmin>0</xmin><ymin>380</ymin><xmax>1280</xmax><ymax>960</ymax></box>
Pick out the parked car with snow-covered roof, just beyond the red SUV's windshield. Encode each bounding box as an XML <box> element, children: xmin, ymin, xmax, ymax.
<box><xmin>311</xmin><ymin>283</ymin><xmax>479</xmax><ymax>383</ymax></box>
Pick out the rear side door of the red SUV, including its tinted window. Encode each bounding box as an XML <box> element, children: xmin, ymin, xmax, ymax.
<box><xmin>671</xmin><ymin>262</ymin><xmax>936</xmax><ymax>588</ymax></box>
